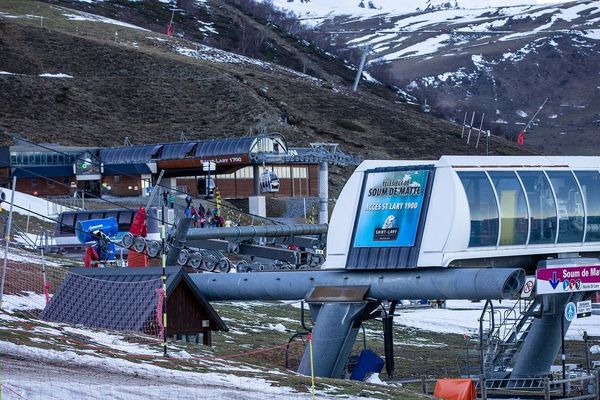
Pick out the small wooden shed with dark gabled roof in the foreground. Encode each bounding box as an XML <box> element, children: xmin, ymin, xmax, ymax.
<box><xmin>41</xmin><ymin>267</ymin><xmax>228</xmax><ymax>346</ymax></box>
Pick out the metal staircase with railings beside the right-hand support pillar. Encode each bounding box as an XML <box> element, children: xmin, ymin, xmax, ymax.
<box><xmin>479</xmin><ymin>298</ymin><xmax>542</xmax><ymax>379</ymax></box>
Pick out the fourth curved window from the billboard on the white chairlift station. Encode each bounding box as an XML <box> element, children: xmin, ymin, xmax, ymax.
<box><xmin>548</xmin><ymin>171</ymin><xmax>583</xmax><ymax>243</ymax></box>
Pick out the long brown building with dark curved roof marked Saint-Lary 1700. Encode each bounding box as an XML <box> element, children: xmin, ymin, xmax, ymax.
<box><xmin>0</xmin><ymin>133</ymin><xmax>356</xmax><ymax>202</ymax></box>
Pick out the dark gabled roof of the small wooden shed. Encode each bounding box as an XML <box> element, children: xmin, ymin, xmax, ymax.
<box><xmin>41</xmin><ymin>267</ymin><xmax>228</xmax><ymax>334</ymax></box>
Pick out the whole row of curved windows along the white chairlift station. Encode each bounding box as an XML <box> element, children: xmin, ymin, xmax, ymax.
<box><xmin>457</xmin><ymin>170</ymin><xmax>600</xmax><ymax>247</ymax></box>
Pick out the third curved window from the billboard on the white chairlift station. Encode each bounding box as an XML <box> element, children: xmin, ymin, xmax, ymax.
<box><xmin>519</xmin><ymin>171</ymin><xmax>558</xmax><ymax>244</ymax></box>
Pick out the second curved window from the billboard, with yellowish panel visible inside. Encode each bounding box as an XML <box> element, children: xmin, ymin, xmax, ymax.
<box><xmin>489</xmin><ymin>171</ymin><xmax>529</xmax><ymax>245</ymax></box>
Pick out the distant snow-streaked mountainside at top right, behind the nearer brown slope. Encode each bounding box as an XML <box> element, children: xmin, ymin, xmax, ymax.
<box><xmin>274</xmin><ymin>0</ymin><xmax>600</xmax><ymax>154</ymax></box>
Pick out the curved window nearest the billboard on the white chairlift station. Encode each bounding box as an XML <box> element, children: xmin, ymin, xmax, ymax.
<box><xmin>458</xmin><ymin>171</ymin><xmax>499</xmax><ymax>247</ymax></box>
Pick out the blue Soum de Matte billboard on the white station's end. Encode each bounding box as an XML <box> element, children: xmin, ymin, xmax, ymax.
<box><xmin>353</xmin><ymin>170</ymin><xmax>429</xmax><ymax>247</ymax></box>
